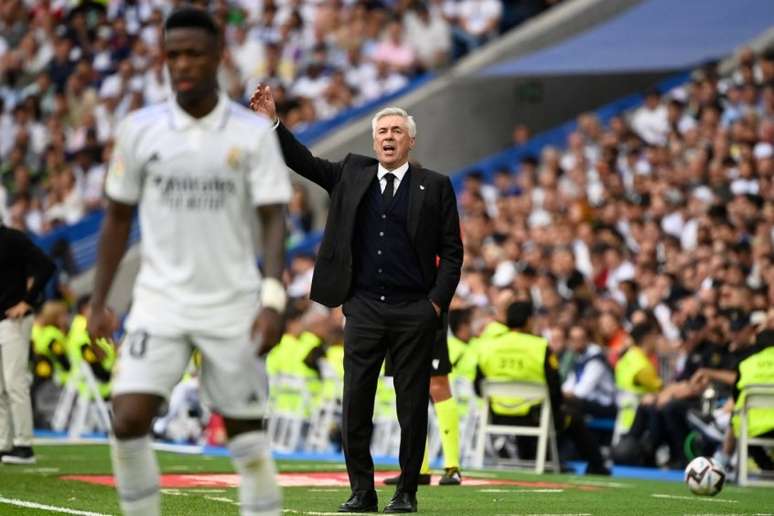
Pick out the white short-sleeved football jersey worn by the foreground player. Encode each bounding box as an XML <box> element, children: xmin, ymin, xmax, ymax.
<box><xmin>105</xmin><ymin>96</ymin><xmax>291</xmax><ymax>335</ymax></box>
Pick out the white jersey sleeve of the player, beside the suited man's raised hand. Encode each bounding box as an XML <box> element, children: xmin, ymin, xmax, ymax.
<box><xmin>249</xmin><ymin>129</ymin><xmax>292</xmax><ymax>206</ymax></box>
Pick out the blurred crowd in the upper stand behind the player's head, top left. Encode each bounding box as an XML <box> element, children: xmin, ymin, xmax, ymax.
<box><xmin>0</xmin><ymin>0</ymin><xmax>556</xmax><ymax>234</ymax></box>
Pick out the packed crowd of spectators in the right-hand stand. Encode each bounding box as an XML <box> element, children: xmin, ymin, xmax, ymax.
<box><xmin>448</xmin><ymin>49</ymin><xmax>774</xmax><ymax>468</ymax></box>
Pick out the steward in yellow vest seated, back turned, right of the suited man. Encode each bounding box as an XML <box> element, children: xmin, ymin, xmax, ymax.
<box><xmin>476</xmin><ymin>301</ymin><xmax>610</xmax><ymax>475</ymax></box>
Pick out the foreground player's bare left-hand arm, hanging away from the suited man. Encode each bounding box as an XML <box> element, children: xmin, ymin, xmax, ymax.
<box><xmin>89</xmin><ymin>200</ymin><xmax>134</xmax><ymax>339</ymax></box>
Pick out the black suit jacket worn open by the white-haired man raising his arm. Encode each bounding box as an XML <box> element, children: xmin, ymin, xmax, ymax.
<box><xmin>277</xmin><ymin>124</ymin><xmax>462</xmax><ymax>310</ymax></box>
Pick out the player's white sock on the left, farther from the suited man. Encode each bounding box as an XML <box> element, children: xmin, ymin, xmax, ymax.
<box><xmin>110</xmin><ymin>435</ymin><xmax>161</xmax><ymax>516</ymax></box>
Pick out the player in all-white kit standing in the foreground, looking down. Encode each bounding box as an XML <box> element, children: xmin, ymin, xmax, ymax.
<box><xmin>89</xmin><ymin>7</ymin><xmax>291</xmax><ymax>516</ymax></box>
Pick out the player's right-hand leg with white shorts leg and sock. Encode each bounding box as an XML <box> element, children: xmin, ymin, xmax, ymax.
<box><xmin>199</xmin><ymin>330</ymin><xmax>282</xmax><ymax>516</ymax></box>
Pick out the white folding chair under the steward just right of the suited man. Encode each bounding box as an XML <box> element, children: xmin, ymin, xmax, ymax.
<box><xmin>476</xmin><ymin>381</ymin><xmax>560</xmax><ymax>473</ymax></box>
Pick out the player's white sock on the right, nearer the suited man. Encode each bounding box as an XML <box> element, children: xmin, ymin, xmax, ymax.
<box><xmin>228</xmin><ymin>432</ymin><xmax>282</xmax><ymax>516</ymax></box>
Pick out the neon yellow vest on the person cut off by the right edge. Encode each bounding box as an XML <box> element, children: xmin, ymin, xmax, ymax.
<box><xmin>733</xmin><ymin>346</ymin><xmax>774</xmax><ymax>437</ymax></box>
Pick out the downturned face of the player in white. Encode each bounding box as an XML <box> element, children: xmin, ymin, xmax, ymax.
<box><xmin>164</xmin><ymin>28</ymin><xmax>221</xmax><ymax>101</ymax></box>
